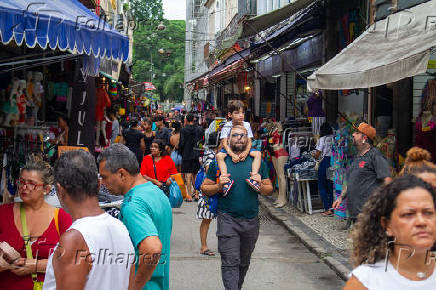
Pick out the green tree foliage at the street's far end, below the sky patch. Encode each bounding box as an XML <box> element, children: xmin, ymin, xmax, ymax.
<box><xmin>133</xmin><ymin>20</ymin><xmax>186</xmax><ymax>101</ymax></box>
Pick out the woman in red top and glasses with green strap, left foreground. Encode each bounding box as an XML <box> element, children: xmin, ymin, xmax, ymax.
<box><xmin>0</xmin><ymin>160</ymin><xmax>72</xmax><ymax>289</ymax></box>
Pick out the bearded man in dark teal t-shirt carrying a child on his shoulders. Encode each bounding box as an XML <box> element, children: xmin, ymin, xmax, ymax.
<box><xmin>201</xmin><ymin>125</ymin><xmax>273</xmax><ymax>290</ymax></box>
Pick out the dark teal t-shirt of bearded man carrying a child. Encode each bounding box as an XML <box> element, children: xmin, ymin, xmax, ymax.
<box><xmin>206</xmin><ymin>156</ymin><xmax>268</xmax><ymax>219</ymax></box>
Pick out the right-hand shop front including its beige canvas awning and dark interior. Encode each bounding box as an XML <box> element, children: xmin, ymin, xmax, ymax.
<box><xmin>308</xmin><ymin>0</ymin><xmax>436</xmax><ymax>169</ymax></box>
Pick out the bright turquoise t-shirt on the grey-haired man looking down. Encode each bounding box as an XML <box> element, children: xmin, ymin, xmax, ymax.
<box><xmin>120</xmin><ymin>182</ymin><xmax>173</xmax><ymax>290</ymax></box>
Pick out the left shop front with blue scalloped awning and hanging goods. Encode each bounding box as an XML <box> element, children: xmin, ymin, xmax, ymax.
<box><xmin>0</xmin><ymin>0</ymin><xmax>129</xmax><ymax>199</ymax></box>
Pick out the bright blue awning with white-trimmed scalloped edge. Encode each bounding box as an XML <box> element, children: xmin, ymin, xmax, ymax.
<box><xmin>0</xmin><ymin>0</ymin><xmax>129</xmax><ymax>61</ymax></box>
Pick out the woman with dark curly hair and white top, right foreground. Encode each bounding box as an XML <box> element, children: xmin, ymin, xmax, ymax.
<box><xmin>344</xmin><ymin>175</ymin><xmax>436</xmax><ymax>290</ymax></box>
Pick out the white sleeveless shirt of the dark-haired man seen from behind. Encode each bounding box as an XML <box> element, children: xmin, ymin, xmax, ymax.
<box><xmin>43</xmin><ymin>213</ymin><xmax>135</xmax><ymax>290</ymax></box>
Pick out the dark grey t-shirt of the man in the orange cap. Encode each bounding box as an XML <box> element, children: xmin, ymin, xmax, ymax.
<box><xmin>347</xmin><ymin>147</ymin><xmax>391</xmax><ymax>218</ymax></box>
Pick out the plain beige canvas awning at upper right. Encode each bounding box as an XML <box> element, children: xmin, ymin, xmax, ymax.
<box><xmin>307</xmin><ymin>0</ymin><xmax>436</xmax><ymax>90</ymax></box>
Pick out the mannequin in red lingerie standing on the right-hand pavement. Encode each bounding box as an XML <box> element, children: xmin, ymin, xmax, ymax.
<box><xmin>271</xmin><ymin>122</ymin><xmax>289</xmax><ymax>208</ymax></box>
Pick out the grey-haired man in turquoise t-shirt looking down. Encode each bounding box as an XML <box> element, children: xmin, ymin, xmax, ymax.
<box><xmin>97</xmin><ymin>144</ymin><xmax>172</xmax><ymax>290</ymax></box>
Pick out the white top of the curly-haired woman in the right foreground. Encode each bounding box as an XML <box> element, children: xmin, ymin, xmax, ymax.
<box><xmin>351</xmin><ymin>261</ymin><xmax>436</xmax><ymax>290</ymax></box>
